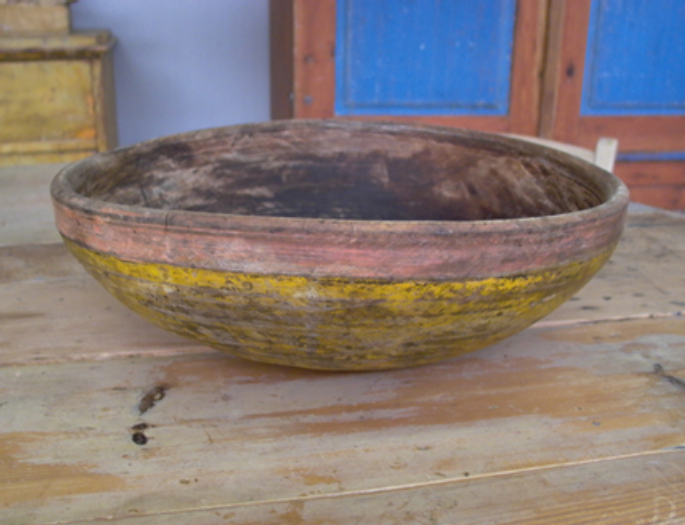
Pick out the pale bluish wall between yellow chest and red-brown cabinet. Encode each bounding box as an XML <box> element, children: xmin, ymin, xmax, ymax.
<box><xmin>71</xmin><ymin>0</ymin><xmax>269</xmax><ymax>146</ymax></box>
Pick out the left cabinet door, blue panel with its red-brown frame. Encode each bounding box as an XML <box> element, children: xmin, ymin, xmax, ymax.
<box><xmin>271</xmin><ymin>0</ymin><xmax>549</xmax><ymax>135</ymax></box>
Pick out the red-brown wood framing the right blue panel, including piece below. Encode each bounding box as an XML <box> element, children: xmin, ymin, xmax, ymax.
<box><xmin>540</xmin><ymin>0</ymin><xmax>685</xmax><ymax>209</ymax></box>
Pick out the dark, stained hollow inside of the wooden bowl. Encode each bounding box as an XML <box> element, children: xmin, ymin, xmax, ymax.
<box><xmin>74</xmin><ymin>123</ymin><xmax>611</xmax><ymax>221</ymax></box>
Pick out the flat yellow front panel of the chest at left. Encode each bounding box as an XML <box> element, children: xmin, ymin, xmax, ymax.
<box><xmin>0</xmin><ymin>60</ymin><xmax>96</xmax><ymax>145</ymax></box>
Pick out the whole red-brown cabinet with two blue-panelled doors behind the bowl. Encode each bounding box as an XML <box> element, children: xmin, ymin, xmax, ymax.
<box><xmin>271</xmin><ymin>0</ymin><xmax>685</xmax><ymax>208</ymax></box>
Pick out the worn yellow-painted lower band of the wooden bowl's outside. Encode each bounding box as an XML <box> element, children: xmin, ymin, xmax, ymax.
<box><xmin>66</xmin><ymin>240</ymin><xmax>613</xmax><ymax>370</ymax></box>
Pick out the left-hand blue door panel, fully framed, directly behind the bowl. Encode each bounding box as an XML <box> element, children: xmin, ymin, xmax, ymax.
<box><xmin>335</xmin><ymin>0</ymin><xmax>516</xmax><ymax>115</ymax></box>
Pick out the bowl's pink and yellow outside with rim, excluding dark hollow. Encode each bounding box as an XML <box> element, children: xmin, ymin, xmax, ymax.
<box><xmin>51</xmin><ymin>121</ymin><xmax>628</xmax><ymax>370</ymax></box>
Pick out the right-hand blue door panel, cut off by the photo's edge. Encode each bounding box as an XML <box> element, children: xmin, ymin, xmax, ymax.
<box><xmin>581</xmin><ymin>0</ymin><xmax>685</xmax><ymax>116</ymax></box>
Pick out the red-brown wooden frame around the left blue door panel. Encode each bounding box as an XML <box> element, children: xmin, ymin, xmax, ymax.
<box><xmin>270</xmin><ymin>0</ymin><xmax>547</xmax><ymax>135</ymax></box>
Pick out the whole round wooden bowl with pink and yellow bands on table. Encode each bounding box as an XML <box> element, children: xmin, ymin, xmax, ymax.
<box><xmin>52</xmin><ymin>120</ymin><xmax>628</xmax><ymax>370</ymax></box>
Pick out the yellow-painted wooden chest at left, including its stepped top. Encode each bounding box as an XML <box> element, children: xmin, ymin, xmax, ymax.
<box><xmin>0</xmin><ymin>0</ymin><xmax>117</xmax><ymax>166</ymax></box>
